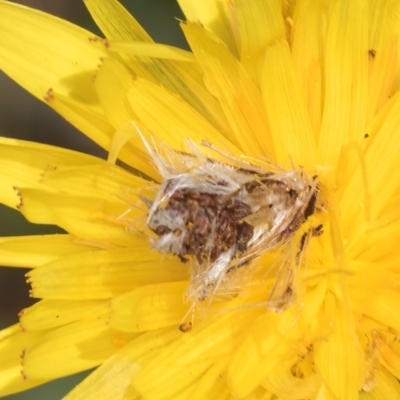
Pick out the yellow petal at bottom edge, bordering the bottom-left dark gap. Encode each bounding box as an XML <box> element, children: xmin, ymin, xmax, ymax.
<box><xmin>64</xmin><ymin>328</ymin><xmax>182</xmax><ymax>400</ymax></box>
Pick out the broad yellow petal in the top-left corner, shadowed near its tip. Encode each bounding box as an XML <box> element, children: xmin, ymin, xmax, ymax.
<box><xmin>0</xmin><ymin>1</ymin><xmax>106</xmax><ymax>104</ymax></box>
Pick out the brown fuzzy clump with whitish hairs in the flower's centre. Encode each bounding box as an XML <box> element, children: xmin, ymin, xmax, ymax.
<box><xmin>142</xmin><ymin>136</ymin><xmax>321</xmax><ymax>312</ymax></box>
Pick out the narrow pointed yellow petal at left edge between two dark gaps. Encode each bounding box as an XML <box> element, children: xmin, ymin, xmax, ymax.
<box><xmin>0</xmin><ymin>235</ymin><xmax>89</xmax><ymax>268</ymax></box>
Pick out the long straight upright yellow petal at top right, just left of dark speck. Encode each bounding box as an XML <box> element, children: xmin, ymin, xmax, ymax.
<box><xmin>319</xmin><ymin>0</ymin><xmax>368</xmax><ymax>165</ymax></box>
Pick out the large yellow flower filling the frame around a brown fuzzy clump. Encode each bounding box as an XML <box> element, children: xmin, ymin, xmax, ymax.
<box><xmin>0</xmin><ymin>0</ymin><xmax>400</xmax><ymax>400</ymax></box>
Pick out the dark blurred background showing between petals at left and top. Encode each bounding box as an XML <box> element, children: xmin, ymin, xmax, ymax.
<box><xmin>0</xmin><ymin>0</ymin><xmax>186</xmax><ymax>400</ymax></box>
